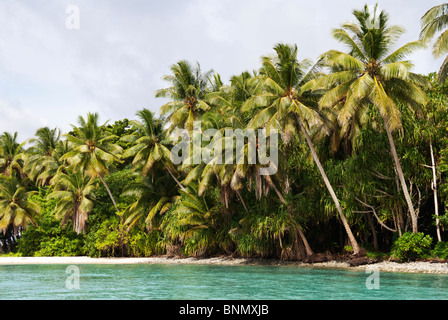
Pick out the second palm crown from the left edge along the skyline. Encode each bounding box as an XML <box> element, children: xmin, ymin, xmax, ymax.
<box><xmin>23</xmin><ymin>127</ymin><xmax>62</xmax><ymax>186</ymax></box>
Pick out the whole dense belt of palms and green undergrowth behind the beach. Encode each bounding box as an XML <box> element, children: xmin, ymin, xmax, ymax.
<box><xmin>0</xmin><ymin>4</ymin><xmax>448</xmax><ymax>261</ymax></box>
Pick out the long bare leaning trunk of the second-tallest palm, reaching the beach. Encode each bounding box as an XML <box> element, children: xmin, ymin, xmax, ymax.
<box><xmin>296</xmin><ymin>115</ymin><xmax>360</xmax><ymax>254</ymax></box>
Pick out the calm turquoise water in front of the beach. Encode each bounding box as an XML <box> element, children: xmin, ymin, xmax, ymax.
<box><xmin>0</xmin><ymin>264</ymin><xmax>448</xmax><ymax>300</ymax></box>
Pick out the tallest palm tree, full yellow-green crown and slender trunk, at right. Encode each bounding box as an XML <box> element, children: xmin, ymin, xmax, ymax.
<box><xmin>317</xmin><ymin>5</ymin><xmax>427</xmax><ymax>232</ymax></box>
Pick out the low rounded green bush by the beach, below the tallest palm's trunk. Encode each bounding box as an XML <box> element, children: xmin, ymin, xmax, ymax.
<box><xmin>392</xmin><ymin>232</ymin><xmax>432</xmax><ymax>262</ymax></box>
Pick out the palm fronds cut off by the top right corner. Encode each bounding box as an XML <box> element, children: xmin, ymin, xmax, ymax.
<box><xmin>420</xmin><ymin>3</ymin><xmax>448</xmax><ymax>83</ymax></box>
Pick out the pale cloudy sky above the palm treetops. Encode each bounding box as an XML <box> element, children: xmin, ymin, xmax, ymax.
<box><xmin>0</xmin><ymin>0</ymin><xmax>442</xmax><ymax>141</ymax></box>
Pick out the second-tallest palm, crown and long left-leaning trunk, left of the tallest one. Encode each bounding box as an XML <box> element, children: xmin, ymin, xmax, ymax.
<box><xmin>243</xmin><ymin>44</ymin><xmax>360</xmax><ymax>254</ymax></box>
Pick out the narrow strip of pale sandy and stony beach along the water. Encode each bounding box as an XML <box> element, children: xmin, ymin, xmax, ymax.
<box><xmin>0</xmin><ymin>256</ymin><xmax>448</xmax><ymax>274</ymax></box>
